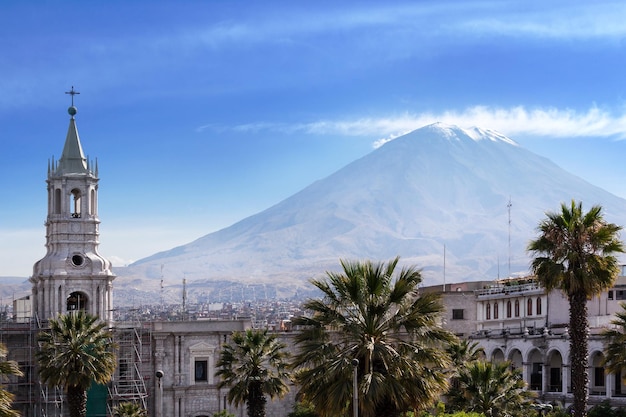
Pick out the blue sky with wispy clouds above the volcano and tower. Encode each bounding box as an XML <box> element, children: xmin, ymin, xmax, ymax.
<box><xmin>0</xmin><ymin>0</ymin><xmax>626</xmax><ymax>276</ymax></box>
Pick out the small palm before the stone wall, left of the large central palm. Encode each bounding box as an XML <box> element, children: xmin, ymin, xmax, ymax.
<box><xmin>215</xmin><ymin>329</ymin><xmax>289</xmax><ymax>417</ymax></box>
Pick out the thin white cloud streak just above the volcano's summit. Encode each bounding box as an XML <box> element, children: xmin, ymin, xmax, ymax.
<box><xmin>223</xmin><ymin>106</ymin><xmax>626</xmax><ymax>146</ymax></box>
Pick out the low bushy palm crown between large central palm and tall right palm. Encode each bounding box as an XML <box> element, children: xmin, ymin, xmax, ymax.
<box><xmin>449</xmin><ymin>360</ymin><xmax>535</xmax><ymax>417</ymax></box>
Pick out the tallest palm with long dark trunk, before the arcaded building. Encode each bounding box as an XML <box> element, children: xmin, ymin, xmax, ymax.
<box><xmin>528</xmin><ymin>200</ymin><xmax>624</xmax><ymax>417</ymax></box>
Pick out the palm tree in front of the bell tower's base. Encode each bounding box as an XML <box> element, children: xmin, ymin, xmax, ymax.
<box><xmin>36</xmin><ymin>311</ymin><xmax>117</xmax><ymax>417</ymax></box>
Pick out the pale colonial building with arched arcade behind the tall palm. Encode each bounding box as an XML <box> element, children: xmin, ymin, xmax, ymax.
<box><xmin>424</xmin><ymin>274</ymin><xmax>626</xmax><ymax>406</ymax></box>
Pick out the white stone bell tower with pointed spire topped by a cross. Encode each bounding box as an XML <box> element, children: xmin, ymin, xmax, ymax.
<box><xmin>30</xmin><ymin>87</ymin><xmax>115</xmax><ymax>323</ymax></box>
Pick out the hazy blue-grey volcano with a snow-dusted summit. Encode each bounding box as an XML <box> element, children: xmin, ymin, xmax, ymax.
<box><xmin>116</xmin><ymin>123</ymin><xmax>626</xmax><ymax>298</ymax></box>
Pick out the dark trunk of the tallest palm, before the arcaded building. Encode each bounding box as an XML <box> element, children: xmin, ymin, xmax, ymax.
<box><xmin>569</xmin><ymin>291</ymin><xmax>589</xmax><ymax>417</ymax></box>
